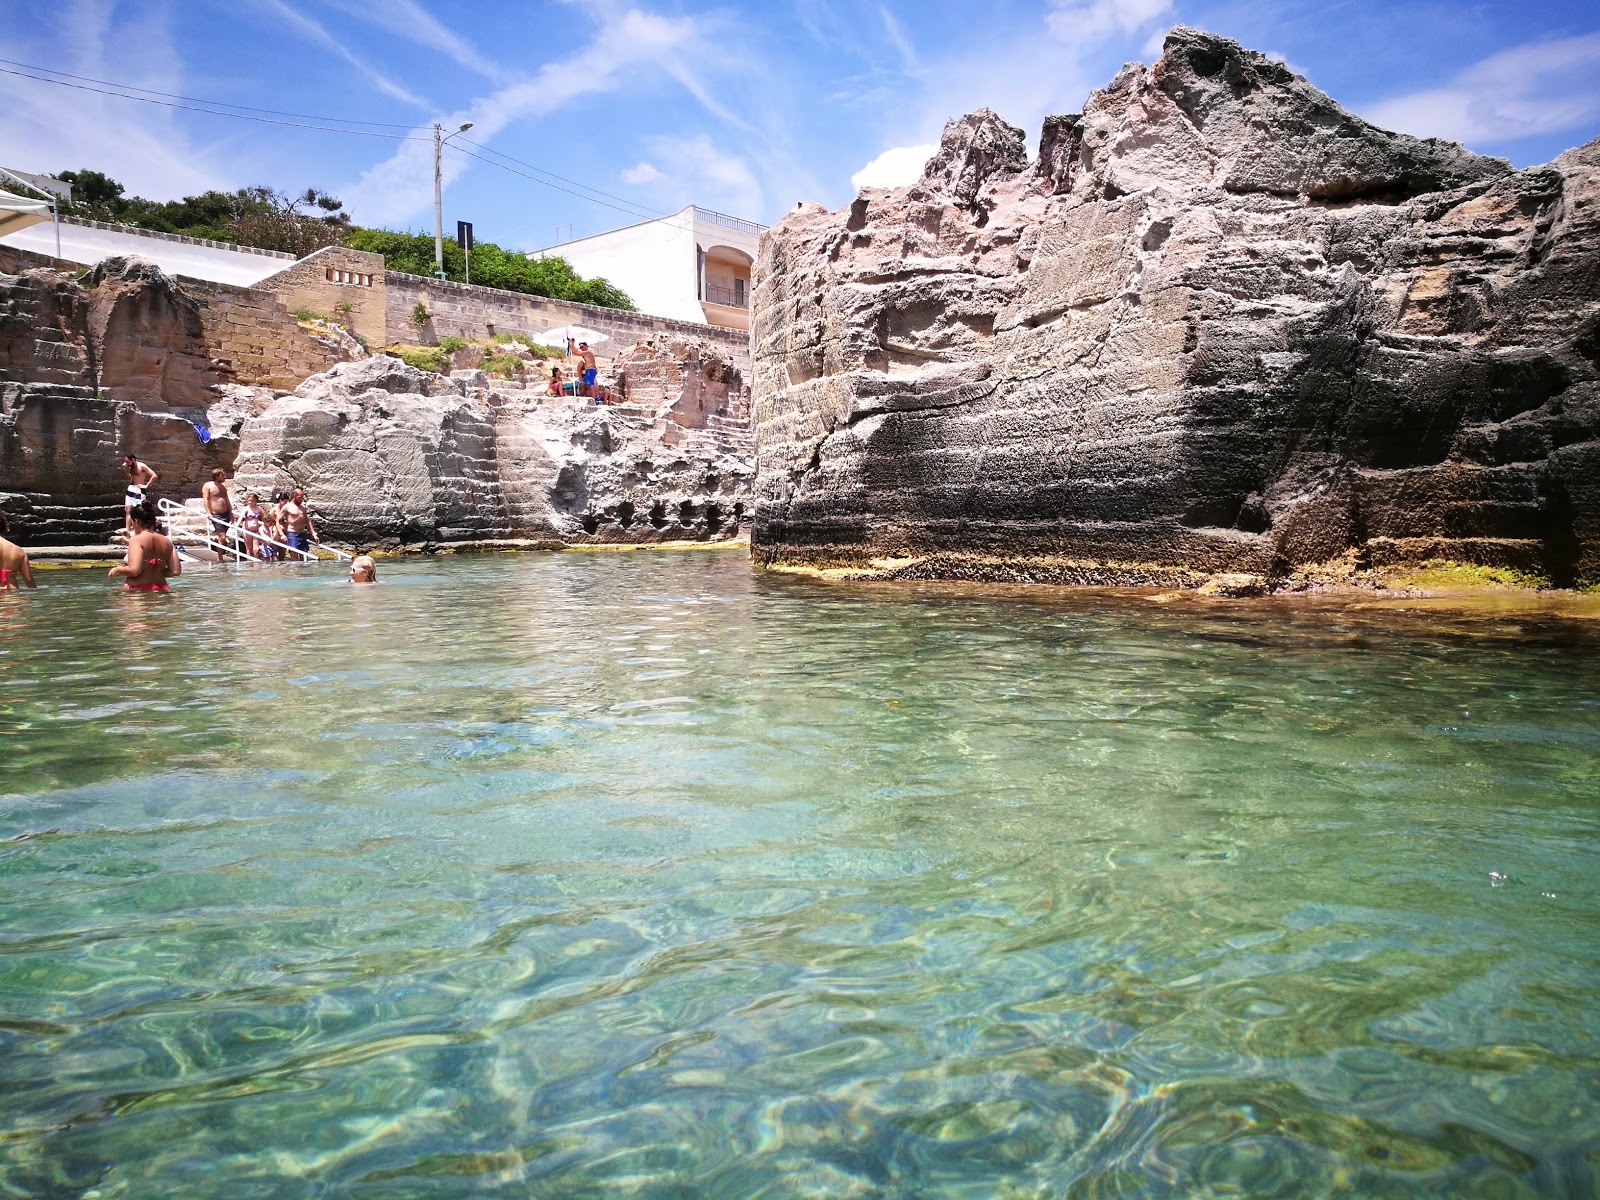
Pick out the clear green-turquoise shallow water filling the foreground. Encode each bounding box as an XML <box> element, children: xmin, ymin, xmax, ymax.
<box><xmin>0</xmin><ymin>554</ymin><xmax>1600</xmax><ymax>1200</ymax></box>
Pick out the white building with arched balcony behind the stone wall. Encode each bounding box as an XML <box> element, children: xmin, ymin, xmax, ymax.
<box><xmin>536</xmin><ymin>205</ymin><xmax>766</xmax><ymax>330</ymax></box>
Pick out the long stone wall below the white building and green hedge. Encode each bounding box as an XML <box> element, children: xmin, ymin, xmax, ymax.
<box><xmin>384</xmin><ymin>270</ymin><xmax>750</xmax><ymax>365</ymax></box>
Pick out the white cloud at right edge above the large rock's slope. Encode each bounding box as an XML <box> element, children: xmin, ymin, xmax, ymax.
<box><xmin>1362</xmin><ymin>34</ymin><xmax>1600</xmax><ymax>147</ymax></box>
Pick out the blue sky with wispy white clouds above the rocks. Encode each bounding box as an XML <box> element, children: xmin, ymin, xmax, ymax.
<box><xmin>0</xmin><ymin>0</ymin><xmax>1600</xmax><ymax>248</ymax></box>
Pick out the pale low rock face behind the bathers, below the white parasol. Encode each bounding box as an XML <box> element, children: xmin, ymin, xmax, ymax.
<box><xmin>237</xmin><ymin>347</ymin><xmax>754</xmax><ymax>546</ymax></box>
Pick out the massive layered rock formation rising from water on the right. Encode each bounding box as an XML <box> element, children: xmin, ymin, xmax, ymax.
<box><xmin>752</xmin><ymin>29</ymin><xmax>1600</xmax><ymax>582</ymax></box>
